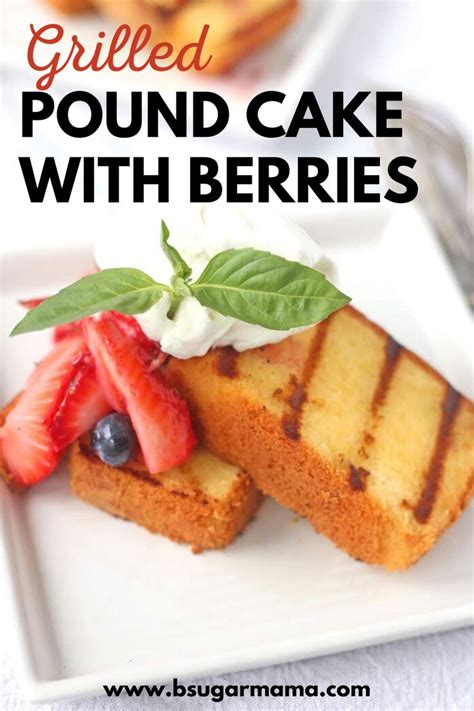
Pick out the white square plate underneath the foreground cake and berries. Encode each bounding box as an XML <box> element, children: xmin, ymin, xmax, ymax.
<box><xmin>1</xmin><ymin>208</ymin><xmax>473</xmax><ymax>702</ymax></box>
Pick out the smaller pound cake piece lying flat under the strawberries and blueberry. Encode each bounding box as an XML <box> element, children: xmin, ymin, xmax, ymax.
<box><xmin>69</xmin><ymin>437</ymin><xmax>261</xmax><ymax>553</ymax></box>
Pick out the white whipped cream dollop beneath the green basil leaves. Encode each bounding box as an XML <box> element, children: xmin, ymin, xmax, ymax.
<box><xmin>95</xmin><ymin>204</ymin><xmax>330</xmax><ymax>358</ymax></box>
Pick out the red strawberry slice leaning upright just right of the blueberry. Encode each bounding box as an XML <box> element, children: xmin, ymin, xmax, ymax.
<box><xmin>84</xmin><ymin>313</ymin><xmax>196</xmax><ymax>474</ymax></box>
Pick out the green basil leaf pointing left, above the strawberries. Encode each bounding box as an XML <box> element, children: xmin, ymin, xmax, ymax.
<box><xmin>10</xmin><ymin>269</ymin><xmax>171</xmax><ymax>336</ymax></box>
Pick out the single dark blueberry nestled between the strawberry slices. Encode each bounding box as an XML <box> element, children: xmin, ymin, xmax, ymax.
<box><xmin>91</xmin><ymin>412</ymin><xmax>136</xmax><ymax>467</ymax></box>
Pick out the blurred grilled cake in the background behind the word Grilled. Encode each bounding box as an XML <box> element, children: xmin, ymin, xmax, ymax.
<box><xmin>46</xmin><ymin>0</ymin><xmax>299</xmax><ymax>74</ymax></box>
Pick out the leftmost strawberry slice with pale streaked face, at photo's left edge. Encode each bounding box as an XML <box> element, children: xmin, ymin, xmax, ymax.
<box><xmin>0</xmin><ymin>336</ymin><xmax>86</xmax><ymax>486</ymax></box>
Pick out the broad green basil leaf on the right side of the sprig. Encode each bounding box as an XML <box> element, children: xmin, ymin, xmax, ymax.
<box><xmin>191</xmin><ymin>248</ymin><xmax>350</xmax><ymax>331</ymax></box>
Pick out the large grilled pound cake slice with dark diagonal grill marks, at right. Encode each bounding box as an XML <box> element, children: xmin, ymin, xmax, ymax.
<box><xmin>165</xmin><ymin>307</ymin><xmax>474</xmax><ymax>570</ymax></box>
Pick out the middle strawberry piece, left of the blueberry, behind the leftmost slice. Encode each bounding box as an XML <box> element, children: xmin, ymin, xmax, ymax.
<box><xmin>46</xmin><ymin>351</ymin><xmax>112</xmax><ymax>451</ymax></box>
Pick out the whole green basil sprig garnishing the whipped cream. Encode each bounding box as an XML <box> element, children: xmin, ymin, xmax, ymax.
<box><xmin>11</xmin><ymin>222</ymin><xmax>350</xmax><ymax>336</ymax></box>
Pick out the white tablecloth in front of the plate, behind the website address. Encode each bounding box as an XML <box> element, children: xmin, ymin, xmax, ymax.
<box><xmin>0</xmin><ymin>628</ymin><xmax>474</xmax><ymax>711</ymax></box>
